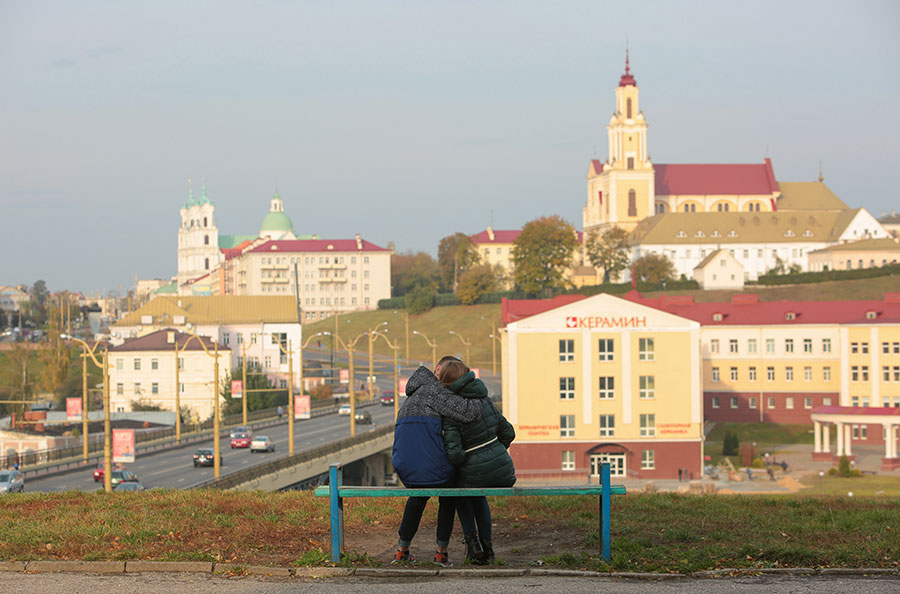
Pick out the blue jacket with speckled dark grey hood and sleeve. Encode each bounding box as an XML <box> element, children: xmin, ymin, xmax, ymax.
<box><xmin>391</xmin><ymin>367</ymin><xmax>482</xmax><ymax>487</ymax></box>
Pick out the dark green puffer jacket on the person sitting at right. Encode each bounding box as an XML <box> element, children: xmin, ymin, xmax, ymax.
<box><xmin>444</xmin><ymin>371</ymin><xmax>516</xmax><ymax>487</ymax></box>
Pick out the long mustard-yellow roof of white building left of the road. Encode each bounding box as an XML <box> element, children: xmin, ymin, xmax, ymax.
<box><xmin>113</xmin><ymin>295</ymin><xmax>297</xmax><ymax>328</ymax></box>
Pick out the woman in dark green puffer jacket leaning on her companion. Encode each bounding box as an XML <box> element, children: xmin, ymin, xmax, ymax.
<box><xmin>437</xmin><ymin>357</ymin><xmax>516</xmax><ymax>564</ymax></box>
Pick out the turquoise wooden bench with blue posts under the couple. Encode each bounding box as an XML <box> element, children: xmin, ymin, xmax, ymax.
<box><xmin>315</xmin><ymin>462</ymin><xmax>625</xmax><ymax>563</ymax></box>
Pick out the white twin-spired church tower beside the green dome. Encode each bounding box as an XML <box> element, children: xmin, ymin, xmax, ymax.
<box><xmin>177</xmin><ymin>180</ymin><xmax>221</xmax><ymax>286</ymax></box>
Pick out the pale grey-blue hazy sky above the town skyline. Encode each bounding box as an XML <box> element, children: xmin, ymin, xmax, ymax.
<box><xmin>0</xmin><ymin>0</ymin><xmax>900</xmax><ymax>293</ymax></box>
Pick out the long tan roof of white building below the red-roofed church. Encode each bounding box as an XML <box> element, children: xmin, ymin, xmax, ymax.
<box><xmin>629</xmin><ymin>208</ymin><xmax>862</xmax><ymax>245</ymax></box>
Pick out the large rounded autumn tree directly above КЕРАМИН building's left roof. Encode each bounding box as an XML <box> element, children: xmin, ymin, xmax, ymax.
<box><xmin>513</xmin><ymin>215</ymin><xmax>578</xmax><ymax>294</ymax></box>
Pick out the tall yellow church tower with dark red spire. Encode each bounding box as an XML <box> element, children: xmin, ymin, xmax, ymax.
<box><xmin>582</xmin><ymin>49</ymin><xmax>655</xmax><ymax>232</ymax></box>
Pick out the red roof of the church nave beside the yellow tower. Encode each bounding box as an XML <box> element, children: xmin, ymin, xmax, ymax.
<box><xmin>653</xmin><ymin>159</ymin><xmax>778</xmax><ymax>196</ymax></box>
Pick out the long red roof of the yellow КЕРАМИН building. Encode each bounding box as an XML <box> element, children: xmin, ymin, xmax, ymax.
<box><xmin>501</xmin><ymin>290</ymin><xmax>900</xmax><ymax>326</ymax></box>
